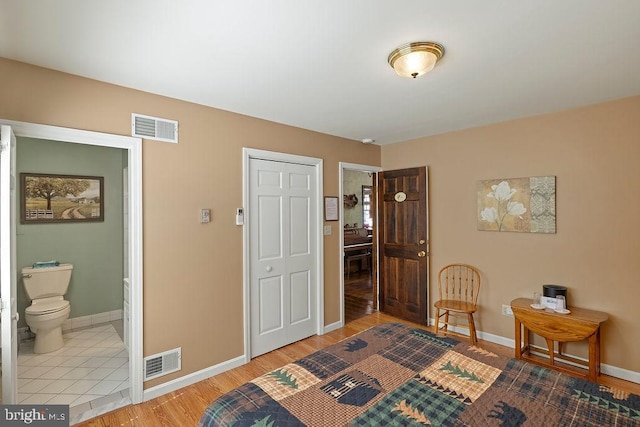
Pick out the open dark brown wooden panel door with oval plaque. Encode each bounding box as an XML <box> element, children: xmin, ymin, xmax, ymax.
<box><xmin>378</xmin><ymin>167</ymin><xmax>429</xmax><ymax>325</ymax></box>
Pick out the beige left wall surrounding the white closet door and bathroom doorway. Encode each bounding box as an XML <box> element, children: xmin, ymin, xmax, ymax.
<box><xmin>0</xmin><ymin>58</ymin><xmax>380</xmax><ymax>388</ymax></box>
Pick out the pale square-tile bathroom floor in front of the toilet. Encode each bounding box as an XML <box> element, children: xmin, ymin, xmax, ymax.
<box><xmin>18</xmin><ymin>323</ymin><xmax>129</xmax><ymax>424</ymax></box>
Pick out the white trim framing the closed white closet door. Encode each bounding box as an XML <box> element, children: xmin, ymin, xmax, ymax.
<box><xmin>242</xmin><ymin>147</ymin><xmax>325</xmax><ymax>363</ymax></box>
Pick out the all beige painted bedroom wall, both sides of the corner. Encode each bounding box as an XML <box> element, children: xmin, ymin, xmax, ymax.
<box><xmin>0</xmin><ymin>58</ymin><xmax>640</xmax><ymax>382</ymax></box>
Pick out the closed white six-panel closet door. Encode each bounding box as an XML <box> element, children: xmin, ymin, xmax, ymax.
<box><xmin>249</xmin><ymin>159</ymin><xmax>318</xmax><ymax>357</ymax></box>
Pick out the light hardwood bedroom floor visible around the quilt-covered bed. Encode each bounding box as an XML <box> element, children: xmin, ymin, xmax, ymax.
<box><xmin>79</xmin><ymin>311</ymin><xmax>640</xmax><ymax>427</ymax></box>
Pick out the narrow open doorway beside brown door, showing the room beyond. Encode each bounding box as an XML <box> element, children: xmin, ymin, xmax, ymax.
<box><xmin>339</xmin><ymin>162</ymin><xmax>382</xmax><ymax>325</ymax></box>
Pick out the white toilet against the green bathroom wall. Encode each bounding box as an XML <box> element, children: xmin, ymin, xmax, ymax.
<box><xmin>22</xmin><ymin>264</ymin><xmax>73</xmax><ymax>353</ymax></box>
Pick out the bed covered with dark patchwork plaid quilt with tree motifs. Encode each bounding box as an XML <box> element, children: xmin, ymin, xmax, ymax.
<box><xmin>198</xmin><ymin>323</ymin><xmax>640</xmax><ymax>427</ymax></box>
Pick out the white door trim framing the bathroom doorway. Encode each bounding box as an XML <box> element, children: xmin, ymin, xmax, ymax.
<box><xmin>0</xmin><ymin>119</ymin><xmax>143</xmax><ymax>404</ymax></box>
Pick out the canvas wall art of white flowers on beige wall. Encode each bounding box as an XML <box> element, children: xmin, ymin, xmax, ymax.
<box><xmin>478</xmin><ymin>176</ymin><xmax>556</xmax><ymax>233</ymax></box>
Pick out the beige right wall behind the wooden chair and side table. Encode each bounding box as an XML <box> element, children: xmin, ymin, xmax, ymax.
<box><xmin>382</xmin><ymin>97</ymin><xmax>640</xmax><ymax>372</ymax></box>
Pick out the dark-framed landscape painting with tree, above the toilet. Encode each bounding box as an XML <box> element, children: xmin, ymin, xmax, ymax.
<box><xmin>20</xmin><ymin>172</ymin><xmax>104</xmax><ymax>224</ymax></box>
